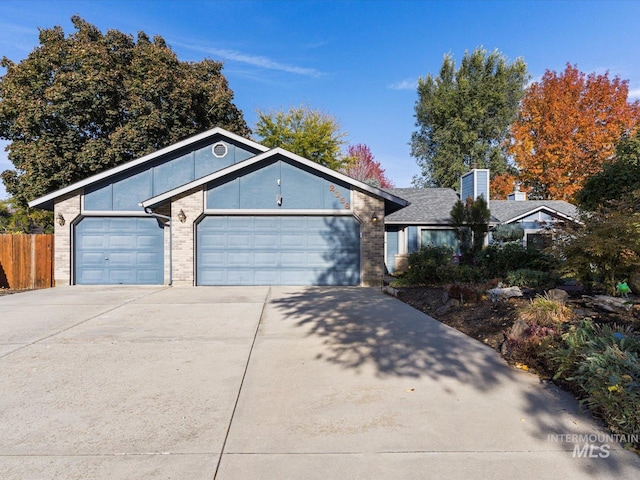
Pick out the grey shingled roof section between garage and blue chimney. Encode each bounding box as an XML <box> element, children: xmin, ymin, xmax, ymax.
<box><xmin>384</xmin><ymin>188</ymin><xmax>459</xmax><ymax>225</ymax></box>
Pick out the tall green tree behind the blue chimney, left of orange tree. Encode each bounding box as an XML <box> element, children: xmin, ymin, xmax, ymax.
<box><xmin>411</xmin><ymin>48</ymin><xmax>529</xmax><ymax>189</ymax></box>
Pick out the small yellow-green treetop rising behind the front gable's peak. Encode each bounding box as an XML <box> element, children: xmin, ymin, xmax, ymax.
<box><xmin>255</xmin><ymin>105</ymin><xmax>350</xmax><ymax>170</ymax></box>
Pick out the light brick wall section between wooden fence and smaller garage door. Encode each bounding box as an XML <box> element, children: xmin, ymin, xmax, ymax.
<box><xmin>53</xmin><ymin>190</ymin><xmax>82</xmax><ymax>286</ymax></box>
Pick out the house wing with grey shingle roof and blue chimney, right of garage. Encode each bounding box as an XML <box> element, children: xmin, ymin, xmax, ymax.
<box><xmin>385</xmin><ymin>169</ymin><xmax>577</xmax><ymax>273</ymax></box>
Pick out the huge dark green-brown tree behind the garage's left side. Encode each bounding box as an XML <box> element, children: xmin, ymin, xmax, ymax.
<box><xmin>0</xmin><ymin>16</ymin><xmax>250</xmax><ymax>204</ymax></box>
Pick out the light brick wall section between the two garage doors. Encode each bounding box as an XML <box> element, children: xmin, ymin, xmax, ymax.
<box><xmin>166</xmin><ymin>187</ymin><xmax>204</xmax><ymax>286</ymax></box>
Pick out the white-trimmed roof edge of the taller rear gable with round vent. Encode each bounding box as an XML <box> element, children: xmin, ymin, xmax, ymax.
<box><xmin>29</xmin><ymin>127</ymin><xmax>269</xmax><ymax>209</ymax></box>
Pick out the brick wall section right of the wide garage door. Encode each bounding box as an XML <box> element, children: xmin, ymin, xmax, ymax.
<box><xmin>353</xmin><ymin>190</ymin><xmax>384</xmax><ymax>287</ymax></box>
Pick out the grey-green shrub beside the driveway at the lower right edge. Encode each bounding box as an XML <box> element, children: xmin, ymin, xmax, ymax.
<box><xmin>551</xmin><ymin>319</ymin><xmax>640</xmax><ymax>448</ymax></box>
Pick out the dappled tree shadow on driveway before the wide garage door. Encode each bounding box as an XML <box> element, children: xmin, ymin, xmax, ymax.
<box><xmin>271</xmin><ymin>287</ymin><xmax>513</xmax><ymax>390</ymax></box>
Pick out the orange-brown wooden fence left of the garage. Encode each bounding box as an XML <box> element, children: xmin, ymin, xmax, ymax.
<box><xmin>0</xmin><ymin>234</ymin><xmax>53</xmax><ymax>289</ymax></box>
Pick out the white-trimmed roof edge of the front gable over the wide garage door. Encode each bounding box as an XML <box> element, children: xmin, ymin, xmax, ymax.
<box><xmin>140</xmin><ymin>147</ymin><xmax>409</xmax><ymax>215</ymax></box>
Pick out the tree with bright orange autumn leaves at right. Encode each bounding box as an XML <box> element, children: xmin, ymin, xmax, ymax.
<box><xmin>509</xmin><ymin>64</ymin><xmax>640</xmax><ymax>200</ymax></box>
